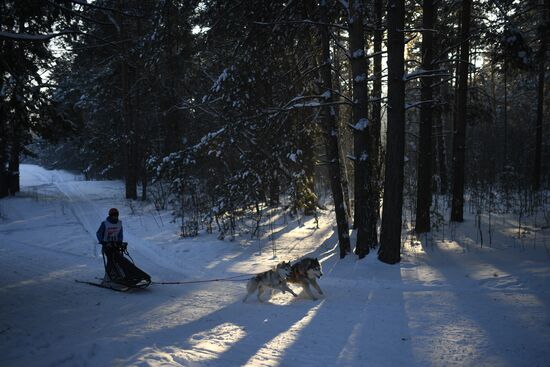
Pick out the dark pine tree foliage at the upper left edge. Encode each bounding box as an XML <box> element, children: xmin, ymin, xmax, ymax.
<box><xmin>0</xmin><ymin>0</ymin><xmax>78</xmax><ymax>197</ymax></box>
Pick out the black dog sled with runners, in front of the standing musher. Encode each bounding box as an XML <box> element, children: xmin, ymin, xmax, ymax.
<box><xmin>76</xmin><ymin>242</ymin><xmax>151</xmax><ymax>292</ymax></box>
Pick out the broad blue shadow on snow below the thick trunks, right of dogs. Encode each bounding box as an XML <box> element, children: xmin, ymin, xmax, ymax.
<box><xmin>280</xmin><ymin>242</ymin><xmax>414</xmax><ymax>366</ymax></box>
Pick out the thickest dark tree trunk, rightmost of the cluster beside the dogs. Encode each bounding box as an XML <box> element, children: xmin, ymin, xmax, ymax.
<box><xmin>378</xmin><ymin>0</ymin><xmax>405</xmax><ymax>264</ymax></box>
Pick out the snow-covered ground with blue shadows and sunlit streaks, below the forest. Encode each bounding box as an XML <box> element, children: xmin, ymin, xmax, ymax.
<box><xmin>0</xmin><ymin>165</ymin><xmax>550</xmax><ymax>367</ymax></box>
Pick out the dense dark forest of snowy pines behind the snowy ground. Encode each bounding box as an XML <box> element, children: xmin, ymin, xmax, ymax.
<box><xmin>0</xmin><ymin>0</ymin><xmax>550</xmax><ymax>263</ymax></box>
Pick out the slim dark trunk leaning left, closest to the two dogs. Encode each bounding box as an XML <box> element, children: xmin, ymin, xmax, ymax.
<box><xmin>319</xmin><ymin>0</ymin><xmax>351</xmax><ymax>259</ymax></box>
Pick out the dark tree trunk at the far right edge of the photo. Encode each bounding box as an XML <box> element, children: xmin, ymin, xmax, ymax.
<box><xmin>533</xmin><ymin>0</ymin><xmax>550</xmax><ymax>191</ymax></box>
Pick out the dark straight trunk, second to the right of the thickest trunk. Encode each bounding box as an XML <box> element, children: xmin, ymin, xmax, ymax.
<box><xmin>451</xmin><ymin>0</ymin><xmax>472</xmax><ymax>222</ymax></box>
